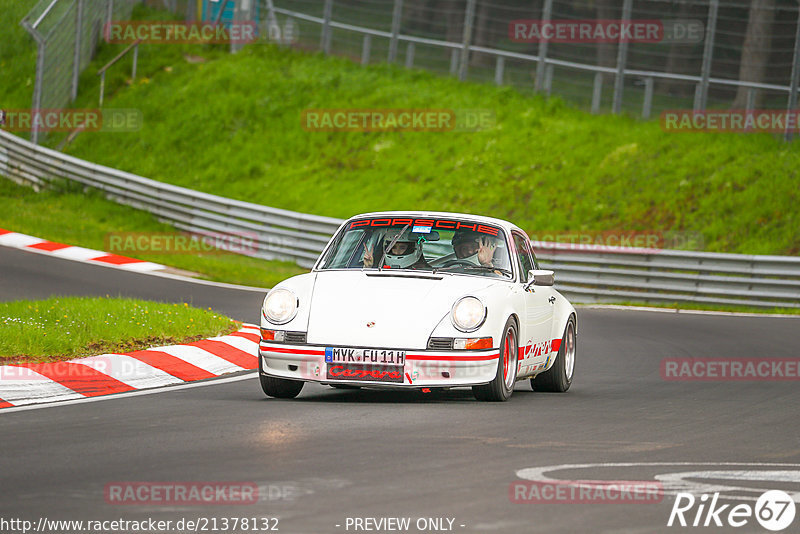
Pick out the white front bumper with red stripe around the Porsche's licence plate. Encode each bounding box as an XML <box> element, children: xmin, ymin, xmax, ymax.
<box><xmin>258</xmin><ymin>340</ymin><xmax>500</xmax><ymax>388</ymax></box>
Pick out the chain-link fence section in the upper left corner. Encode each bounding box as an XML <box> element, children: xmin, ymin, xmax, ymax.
<box><xmin>21</xmin><ymin>0</ymin><xmax>141</xmax><ymax>143</ymax></box>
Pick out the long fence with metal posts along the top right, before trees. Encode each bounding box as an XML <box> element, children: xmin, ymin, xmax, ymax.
<box><xmin>268</xmin><ymin>0</ymin><xmax>800</xmax><ymax>137</ymax></box>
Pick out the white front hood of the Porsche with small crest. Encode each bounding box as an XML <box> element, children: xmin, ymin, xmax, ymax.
<box><xmin>308</xmin><ymin>271</ymin><xmax>498</xmax><ymax>350</ymax></box>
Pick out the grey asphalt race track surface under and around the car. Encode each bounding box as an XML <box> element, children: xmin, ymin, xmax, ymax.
<box><xmin>0</xmin><ymin>247</ymin><xmax>800</xmax><ymax>533</ymax></box>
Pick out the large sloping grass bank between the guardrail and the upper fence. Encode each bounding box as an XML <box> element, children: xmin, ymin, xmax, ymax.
<box><xmin>59</xmin><ymin>45</ymin><xmax>800</xmax><ymax>254</ymax></box>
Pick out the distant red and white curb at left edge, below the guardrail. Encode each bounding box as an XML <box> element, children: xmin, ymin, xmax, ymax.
<box><xmin>0</xmin><ymin>228</ymin><xmax>167</xmax><ymax>272</ymax></box>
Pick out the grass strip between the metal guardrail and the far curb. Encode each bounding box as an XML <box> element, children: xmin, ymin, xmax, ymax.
<box><xmin>0</xmin><ymin>179</ymin><xmax>305</xmax><ymax>287</ymax></box>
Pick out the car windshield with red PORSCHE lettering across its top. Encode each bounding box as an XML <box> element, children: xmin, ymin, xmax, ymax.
<box><xmin>318</xmin><ymin>217</ymin><xmax>513</xmax><ymax>279</ymax></box>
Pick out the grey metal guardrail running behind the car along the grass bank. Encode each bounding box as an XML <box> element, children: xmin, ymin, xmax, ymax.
<box><xmin>0</xmin><ymin>130</ymin><xmax>800</xmax><ymax>308</ymax></box>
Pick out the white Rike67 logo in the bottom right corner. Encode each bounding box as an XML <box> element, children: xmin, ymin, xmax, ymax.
<box><xmin>667</xmin><ymin>490</ymin><xmax>796</xmax><ymax>532</ymax></box>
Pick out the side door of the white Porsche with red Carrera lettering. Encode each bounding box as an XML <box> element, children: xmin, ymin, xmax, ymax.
<box><xmin>512</xmin><ymin>231</ymin><xmax>554</xmax><ymax>375</ymax></box>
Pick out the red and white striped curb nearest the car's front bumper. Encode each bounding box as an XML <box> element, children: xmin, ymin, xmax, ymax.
<box><xmin>0</xmin><ymin>324</ymin><xmax>260</xmax><ymax>408</ymax></box>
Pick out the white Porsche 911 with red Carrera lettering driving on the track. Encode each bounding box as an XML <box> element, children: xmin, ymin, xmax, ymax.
<box><xmin>259</xmin><ymin>212</ymin><xmax>577</xmax><ymax>401</ymax></box>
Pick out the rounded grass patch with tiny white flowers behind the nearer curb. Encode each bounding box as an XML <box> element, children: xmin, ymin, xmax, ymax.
<box><xmin>0</xmin><ymin>297</ymin><xmax>241</xmax><ymax>363</ymax></box>
